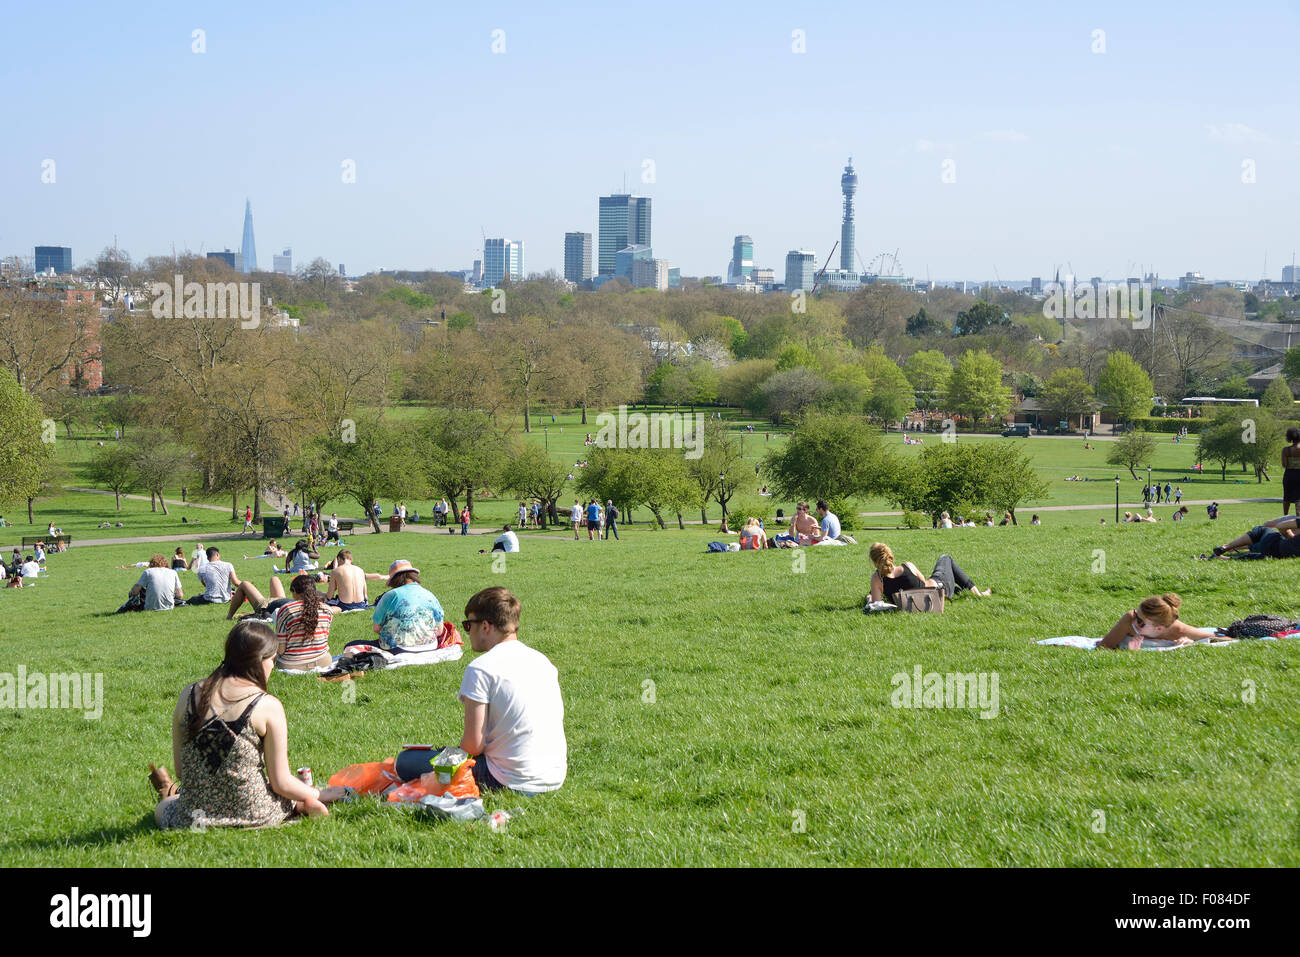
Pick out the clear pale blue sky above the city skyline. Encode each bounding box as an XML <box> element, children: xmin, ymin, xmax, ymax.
<box><xmin>0</xmin><ymin>0</ymin><xmax>1300</xmax><ymax>280</ymax></box>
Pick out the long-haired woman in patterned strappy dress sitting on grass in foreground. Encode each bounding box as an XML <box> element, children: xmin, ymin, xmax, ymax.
<box><xmin>150</xmin><ymin>622</ymin><xmax>345</xmax><ymax>828</ymax></box>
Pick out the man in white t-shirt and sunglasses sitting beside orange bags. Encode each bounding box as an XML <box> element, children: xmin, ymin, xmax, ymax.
<box><xmin>460</xmin><ymin>586</ymin><xmax>568</xmax><ymax>794</ymax></box>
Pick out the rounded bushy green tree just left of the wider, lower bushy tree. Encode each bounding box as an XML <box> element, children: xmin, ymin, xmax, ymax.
<box><xmin>763</xmin><ymin>412</ymin><xmax>897</xmax><ymax>509</ymax></box>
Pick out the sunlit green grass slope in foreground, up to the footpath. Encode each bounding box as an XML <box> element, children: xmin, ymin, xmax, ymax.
<box><xmin>0</xmin><ymin>496</ymin><xmax>1300</xmax><ymax>867</ymax></box>
